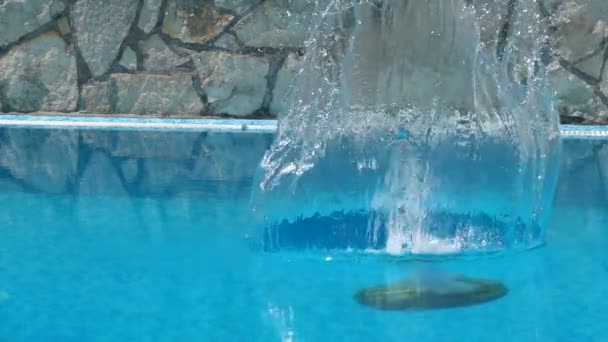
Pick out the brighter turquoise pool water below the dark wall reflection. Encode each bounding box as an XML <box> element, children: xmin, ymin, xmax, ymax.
<box><xmin>0</xmin><ymin>183</ymin><xmax>608</xmax><ymax>341</ymax></box>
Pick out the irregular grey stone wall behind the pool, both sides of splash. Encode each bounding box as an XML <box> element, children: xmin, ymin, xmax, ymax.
<box><xmin>0</xmin><ymin>0</ymin><xmax>608</xmax><ymax>123</ymax></box>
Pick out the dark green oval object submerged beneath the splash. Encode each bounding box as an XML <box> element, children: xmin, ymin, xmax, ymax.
<box><xmin>355</xmin><ymin>275</ymin><xmax>508</xmax><ymax>310</ymax></box>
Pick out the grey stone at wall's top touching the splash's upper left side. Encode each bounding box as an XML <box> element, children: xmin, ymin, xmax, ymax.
<box><xmin>234</xmin><ymin>0</ymin><xmax>315</xmax><ymax>48</ymax></box>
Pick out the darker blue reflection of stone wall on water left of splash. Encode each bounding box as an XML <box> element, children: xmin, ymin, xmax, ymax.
<box><xmin>0</xmin><ymin>128</ymin><xmax>273</xmax><ymax>195</ymax></box>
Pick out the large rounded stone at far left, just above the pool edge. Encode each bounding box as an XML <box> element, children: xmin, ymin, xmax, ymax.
<box><xmin>0</xmin><ymin>32</ymin><xmax>78</xmax><ymax>112</ymax></box>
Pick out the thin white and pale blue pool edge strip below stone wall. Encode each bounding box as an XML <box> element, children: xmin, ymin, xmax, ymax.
<box><xmin>0</xmin><ymin>113</ymin><xmax>608</xmax><ymax>139</ymax></box>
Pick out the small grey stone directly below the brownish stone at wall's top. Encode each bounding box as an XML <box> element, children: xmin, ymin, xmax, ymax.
<box><xmin>139</xmin><ymin>35</ymin><xmax>189</xmax><ymax>71</ymax></box>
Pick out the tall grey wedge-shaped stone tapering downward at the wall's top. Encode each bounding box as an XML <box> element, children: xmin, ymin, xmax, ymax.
<box><xmin>71</xmin><ymin>0</ymin><xmax>138</xmax><ymax>77</ymax></box>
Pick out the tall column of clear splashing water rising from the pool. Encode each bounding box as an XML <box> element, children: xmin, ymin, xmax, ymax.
<box><xmin>255</xmin><ymin>0</ymin><xmax>560</xmax><ymax>255</ymax></box>
